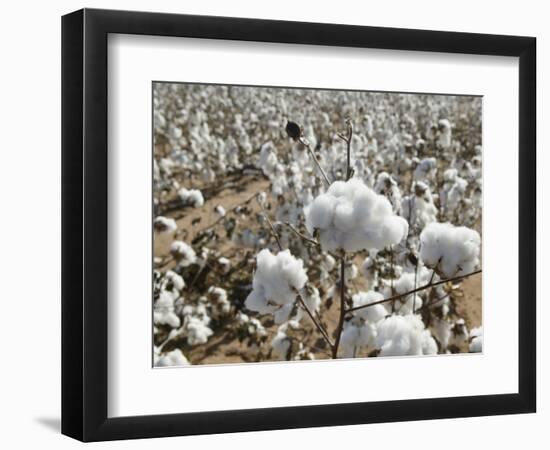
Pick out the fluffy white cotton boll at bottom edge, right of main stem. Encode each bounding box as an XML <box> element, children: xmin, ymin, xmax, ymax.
<box><xmin>376</xmin><ymin>314</ymin><xmax>433</xmax><ymax>356</ymax></box>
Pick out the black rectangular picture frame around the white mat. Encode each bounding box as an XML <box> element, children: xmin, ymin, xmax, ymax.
<box><xmin>62</xmin><ymin>9</ymin><xmax>536</xmax><ymax>441</ymax></box>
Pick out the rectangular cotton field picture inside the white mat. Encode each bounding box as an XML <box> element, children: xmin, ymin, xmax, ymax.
<box><xmin>152</xmin><ymin>83</ymin><xmax>483</xmax><ymax>367</ymax></box>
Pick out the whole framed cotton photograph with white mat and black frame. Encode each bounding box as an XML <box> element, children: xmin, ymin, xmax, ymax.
<box><xmin>62</xmin><ymin>9</ymin><xmax>536</xmax><ymax>441</ymax></box>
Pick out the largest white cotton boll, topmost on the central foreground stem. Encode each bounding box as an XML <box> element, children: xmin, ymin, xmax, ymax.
<box><xmin>304</xmin><ymin>178</ymin><xmax>408</xmax><ymax>252</ymax></box>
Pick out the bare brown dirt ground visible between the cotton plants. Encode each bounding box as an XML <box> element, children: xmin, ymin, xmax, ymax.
<box><xmin>154</xmin><ymin>176</ymin><xmax>482</xmax><ymax>364</ymax></box>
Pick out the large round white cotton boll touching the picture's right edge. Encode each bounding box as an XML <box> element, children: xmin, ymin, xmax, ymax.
<box><xmin>420</xmin><ymin>222</ymin><xmax>481</xmax><ymax>278</ymax></box>
